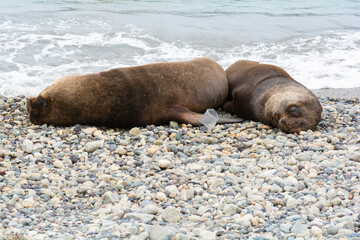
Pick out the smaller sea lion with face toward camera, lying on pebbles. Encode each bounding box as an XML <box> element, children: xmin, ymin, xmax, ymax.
<box><xmin>223</xmin><ymin>60</ymin><xmax>322</xmax><ymax>133</ymax></box>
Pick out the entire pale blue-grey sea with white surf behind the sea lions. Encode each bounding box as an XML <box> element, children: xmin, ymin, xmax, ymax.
<box><xmin>0</xmin><ymin>0</ymin><xmax>360</xmax><ymax>96</ymax></box>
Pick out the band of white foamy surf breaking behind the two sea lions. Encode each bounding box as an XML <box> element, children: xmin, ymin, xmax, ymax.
<box><xmin>0</xmin><ymin>21</ymin><xmax>360</xmax><ymax>96</ymax></box>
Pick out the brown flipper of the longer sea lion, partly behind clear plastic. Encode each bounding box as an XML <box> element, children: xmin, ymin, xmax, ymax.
<box><xmin>170</xmin><ymin>107</ymin><xmax>244</xmax><ymax>126</ymax></box>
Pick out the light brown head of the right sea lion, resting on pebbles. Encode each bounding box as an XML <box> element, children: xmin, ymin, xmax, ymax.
<box><xmin>265</xmin><ymin>87</ymin><xmax>322</xmax><ymax>133</ymax></box>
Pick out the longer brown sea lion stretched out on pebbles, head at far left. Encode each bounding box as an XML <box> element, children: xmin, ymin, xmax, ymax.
<box><xmin>27</xmin><ymin>58</ymin><xmax>241</xmax><ymax>128</ymax></box>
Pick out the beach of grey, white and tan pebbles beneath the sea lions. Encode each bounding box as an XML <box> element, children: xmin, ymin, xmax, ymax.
<box><xmin>0</xmin><ymin>96</ymin><xmax>360</xmax><ymax>240</ymax></box>
